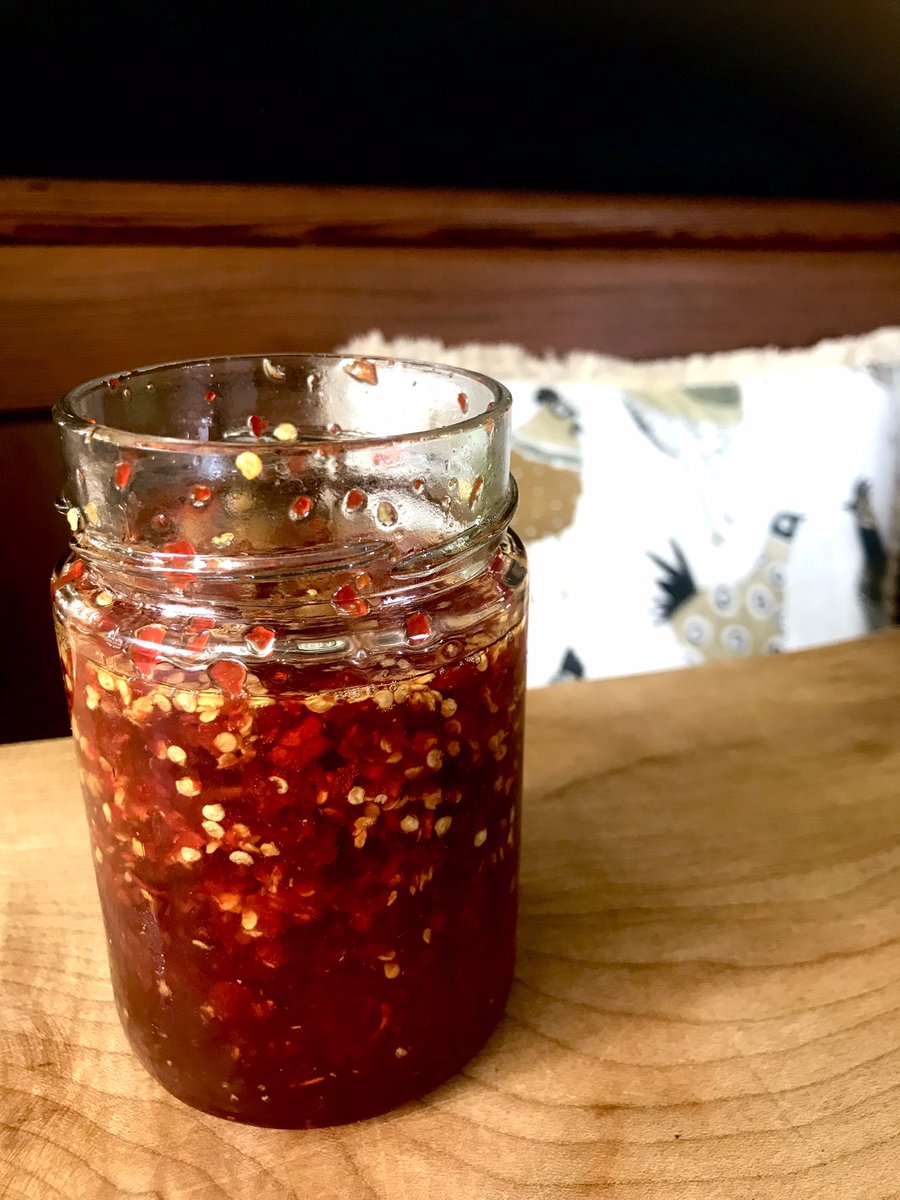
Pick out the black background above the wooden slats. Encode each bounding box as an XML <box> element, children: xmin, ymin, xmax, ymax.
<box><xmin>0</xmin><ymin>0</ymin><xmax>900</xmax><ymax>199</ymax></box>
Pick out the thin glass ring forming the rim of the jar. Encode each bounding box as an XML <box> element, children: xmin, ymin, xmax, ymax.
<box><xmin>53</xmin><ymin>350</ymin><xmax>512</xmax><ymax>455</ymax></box>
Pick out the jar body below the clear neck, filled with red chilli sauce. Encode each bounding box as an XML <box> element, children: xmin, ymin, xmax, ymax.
<box><xmin>55</xmin><ymin>352</ymin><xmax>526</xmax><ymax>1127</ymax></box>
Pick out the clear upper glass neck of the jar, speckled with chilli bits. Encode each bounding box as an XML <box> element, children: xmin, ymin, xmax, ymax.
<box><xmin>55</xmin><ymin>355</ymin><xmax>515</xmax><ymax>588</ymax></box>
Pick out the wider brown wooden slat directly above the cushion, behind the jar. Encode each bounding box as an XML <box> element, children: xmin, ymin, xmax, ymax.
<box><xmin>0</xmin><ymin>246</ymin><xmax>900</xmax><ymax>409</ymax></box>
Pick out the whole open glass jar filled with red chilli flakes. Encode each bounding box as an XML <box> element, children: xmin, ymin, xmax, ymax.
<box><xmin>53</xmin><ymin>355</ymin><xmax>526</xmax><ymax>1128</ymax></box>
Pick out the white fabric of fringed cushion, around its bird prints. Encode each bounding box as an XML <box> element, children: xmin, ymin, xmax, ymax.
<box><xmin>347</xmin><ymin>329</ymin><xmax>900</xmax><ymax>685</ymax></box>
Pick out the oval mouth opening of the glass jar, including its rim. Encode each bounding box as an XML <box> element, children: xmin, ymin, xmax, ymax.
<box><xmin>53</xmin><ymin>353</ymin><xmax>512</xmax><ymax>456</ymax></box>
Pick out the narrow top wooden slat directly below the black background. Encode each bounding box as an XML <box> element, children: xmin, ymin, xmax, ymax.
<box><xmin>0</xmin><ymin>179</ymin><xmax>900</xmax><ymax>250</ymax></box>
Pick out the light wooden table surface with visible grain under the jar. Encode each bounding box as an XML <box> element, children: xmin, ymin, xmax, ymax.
<box><xmin>0</xmin><ymin>632</ymin><xmax>900</xmax><ymax>1200</ymax></box>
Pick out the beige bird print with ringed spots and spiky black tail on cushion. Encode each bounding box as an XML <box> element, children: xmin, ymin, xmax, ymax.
<box><xmin>649</xmin><ymin>512</ymin><xmax>803</xmax><ymax>662</ymax></box>
